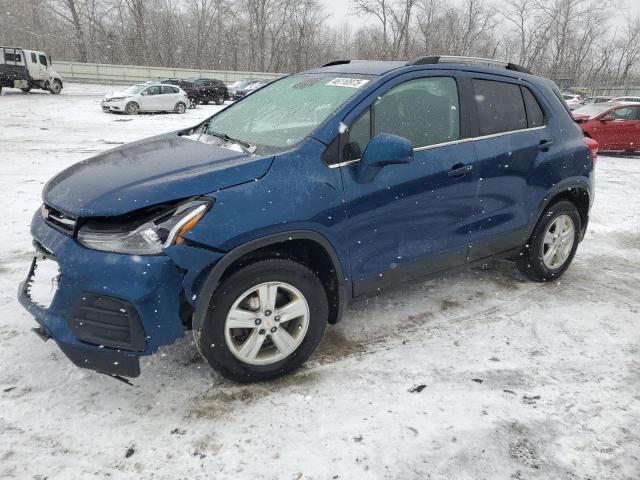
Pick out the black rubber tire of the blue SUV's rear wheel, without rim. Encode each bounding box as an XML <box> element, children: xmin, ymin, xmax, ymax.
<box><xmin>516</xmin><ymin>200</ymin><xmax>582</xmax><ymax>282</ymax></box>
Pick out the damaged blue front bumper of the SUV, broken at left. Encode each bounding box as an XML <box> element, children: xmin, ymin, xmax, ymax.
<box><xmin>18</xmin><ymin>212</ymin><xmax>222</xmax><ymax>377</ymax></box>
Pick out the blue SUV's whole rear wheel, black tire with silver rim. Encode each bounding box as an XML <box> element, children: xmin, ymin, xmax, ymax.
<box><xmin>516</xmin><ymin>200</ymin><xmax>582</xmax><ymax>282</ymax></box>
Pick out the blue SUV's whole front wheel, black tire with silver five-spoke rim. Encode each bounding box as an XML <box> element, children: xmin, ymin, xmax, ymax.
<box><xmin>194</xmin><ymin>259</ymin><xmax>329</xmax><ymax>382</ymax></box>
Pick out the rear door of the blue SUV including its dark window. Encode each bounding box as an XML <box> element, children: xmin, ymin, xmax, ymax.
<box><xmin>469</xmin><ymin>74</ymin><xmax>554</xmax><ymax>261</ymax></box>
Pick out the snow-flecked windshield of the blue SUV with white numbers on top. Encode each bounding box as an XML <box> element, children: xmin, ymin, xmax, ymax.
<box><xmin>205</xmin><ymin>73</ymin><xmax>372</xmax><ymax>148</ymax></box>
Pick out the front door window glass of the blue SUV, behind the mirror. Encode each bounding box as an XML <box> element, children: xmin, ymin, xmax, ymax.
<box><xmin>374</xmin><ymin>77</ymin><xmax>460</xmax><ymax>148</ymax></box>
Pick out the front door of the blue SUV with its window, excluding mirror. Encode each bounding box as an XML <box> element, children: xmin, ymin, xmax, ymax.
<box><xmin>341</xmin><ymin>73</ymin><xmax>477</xmax><ymax>295</ymax></box>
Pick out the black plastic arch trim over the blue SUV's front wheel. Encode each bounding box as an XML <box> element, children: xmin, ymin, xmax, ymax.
<box><xmin>193</xmin><ymin>230</ymin><xmax>348</xmax><ymax>330</ymax></box>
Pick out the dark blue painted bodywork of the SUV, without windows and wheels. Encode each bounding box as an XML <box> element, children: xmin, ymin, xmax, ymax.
<box><xmin>16</xmin><ymin>62</ymin><xmax>593</xmax><ymax>376</ymax></box>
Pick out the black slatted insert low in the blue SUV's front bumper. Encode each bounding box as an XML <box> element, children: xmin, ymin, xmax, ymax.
<box><xmin>69</xmin><ymin>294</ymin><xmax>147</xmax><ymax>352</ymax></box>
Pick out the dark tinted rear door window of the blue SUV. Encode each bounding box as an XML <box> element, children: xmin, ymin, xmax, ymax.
<box><xmin>473</xmin><ymin>79</ymin><xmax>527</xmax><ymax>136</ymax></box>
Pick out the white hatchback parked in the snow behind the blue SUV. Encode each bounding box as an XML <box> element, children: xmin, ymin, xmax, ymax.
<box><xmin>100</xmin><ymin>84</ymin><xmax>189</xmax><ymax>115</ymax></box>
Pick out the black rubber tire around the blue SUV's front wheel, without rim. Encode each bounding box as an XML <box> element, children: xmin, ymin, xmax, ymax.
<box><xmin>194</xmin><ymin>259</ymin><xmax>329</xmax><ymax>383</ymax></box>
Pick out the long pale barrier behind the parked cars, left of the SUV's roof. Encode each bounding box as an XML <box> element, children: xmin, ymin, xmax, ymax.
<box><xmin>53</xmin><ymin>61</ymin><xmax>287</xmax><ymax>84</ymax></box>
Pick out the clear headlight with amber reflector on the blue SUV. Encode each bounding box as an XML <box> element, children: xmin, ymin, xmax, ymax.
<box><xmin>78</xmin><ymin>200</ymin><xmax>211</xmax><ymax>255</ymax></box>
